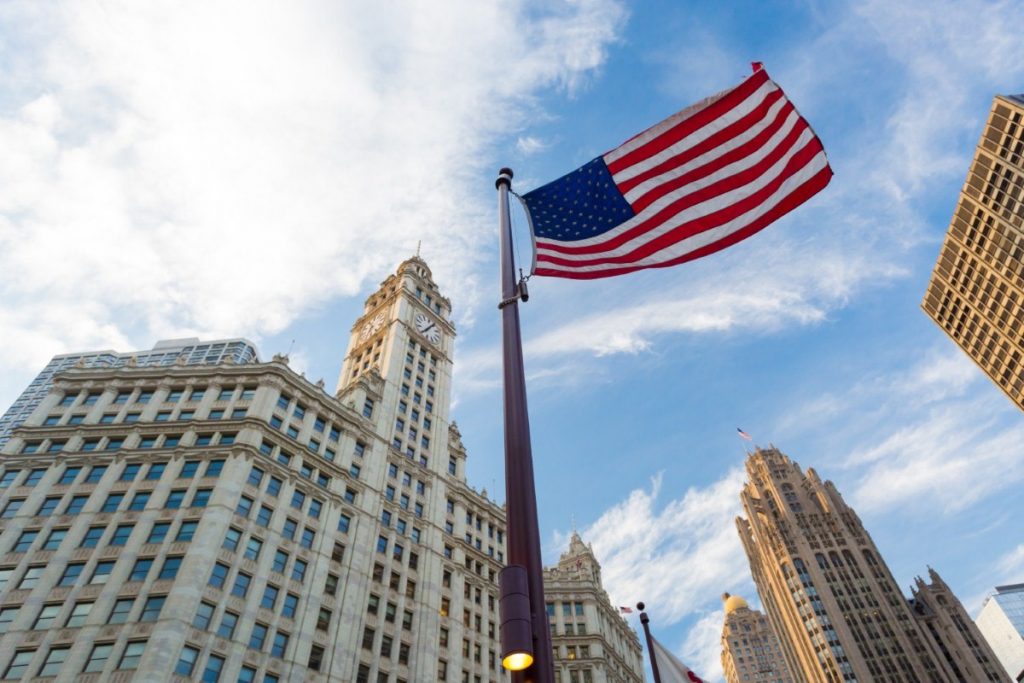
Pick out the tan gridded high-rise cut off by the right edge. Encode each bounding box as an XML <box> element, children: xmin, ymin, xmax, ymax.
<box><xmin>922</xmin><ymin>95</ymin><xmax>1024</xmax><ymax>409</ymax></box>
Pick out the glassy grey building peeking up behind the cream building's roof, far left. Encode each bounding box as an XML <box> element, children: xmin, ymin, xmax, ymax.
<box><xmin>0</xmin><ymin>338</ymin><xmax>259</xmax><ymax>447</ymax></box>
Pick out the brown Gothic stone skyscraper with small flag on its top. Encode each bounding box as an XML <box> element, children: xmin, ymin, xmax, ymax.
<box><xmin>736</xmin><ymin>447</ymin><xmax>1009</xmax><ymax>683</ymax></box>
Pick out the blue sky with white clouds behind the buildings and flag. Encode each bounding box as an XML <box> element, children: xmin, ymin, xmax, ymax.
<box><xmin>0</xmin><ymin>0</ymin><xmax>1024</xmax><ymax>680</ymax></box>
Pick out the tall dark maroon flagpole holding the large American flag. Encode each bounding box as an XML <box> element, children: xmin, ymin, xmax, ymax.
<box><xmin>495</xmin><ymin>168</ymin><xmax>554</xmax><ymax>683</ymax></box>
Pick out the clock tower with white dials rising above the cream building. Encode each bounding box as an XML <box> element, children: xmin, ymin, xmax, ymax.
<box><xmin>338</xmin><ymin>256</ymin><xmax>455</xmax><ymax>473</ymax></box>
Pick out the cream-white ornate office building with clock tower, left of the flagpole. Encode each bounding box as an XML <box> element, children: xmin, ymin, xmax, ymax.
<box><xmin>0</xmin><ymin>258</ymin><xmax>507</xmax><ymax>683</ymax></box>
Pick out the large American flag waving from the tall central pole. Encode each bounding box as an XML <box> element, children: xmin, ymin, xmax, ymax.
<box><xmin>521</xmin><ymin>65</ymin><xmax>833</xmax><ymax>279</ymax></box>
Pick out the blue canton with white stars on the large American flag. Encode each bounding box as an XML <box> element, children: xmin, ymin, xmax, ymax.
<box><xmin>523</xmin><ymin>157</ymin><xmax>634</xmax><ymax>242</ymax></box>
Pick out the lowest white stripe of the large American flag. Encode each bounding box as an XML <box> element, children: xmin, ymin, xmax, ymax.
<box><xmin>538</xmin><ymin>153</ymin><xmax>828</xmax><ymax>274</ymax></box>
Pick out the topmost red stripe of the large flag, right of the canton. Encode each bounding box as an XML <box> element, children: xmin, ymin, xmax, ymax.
<box><xmin>604</xmin><ymin>71</ymin><xmax>769</xmax><ymax>173</ymax></box>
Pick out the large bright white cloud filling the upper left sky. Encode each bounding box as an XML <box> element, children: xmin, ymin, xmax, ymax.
<box><xmin>0</xmin><ymin>0</ymin><xmax>625</xmax><ymax>405</ymax></box>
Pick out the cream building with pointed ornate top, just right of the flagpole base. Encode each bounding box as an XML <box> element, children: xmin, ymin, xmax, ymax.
<box><xmin>544</xmin><ymin>531</ymin><xmax>643</xmax><ymax>683</ymax></box>
